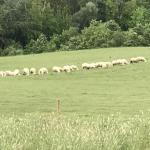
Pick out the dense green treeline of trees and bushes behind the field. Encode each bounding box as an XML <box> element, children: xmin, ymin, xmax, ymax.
<box><xmin>0</xmin><ymin>0</ymin><xmax>150</xmax><ymax>56</ymax></box>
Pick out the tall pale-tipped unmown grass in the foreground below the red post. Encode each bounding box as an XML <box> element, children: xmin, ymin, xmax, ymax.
<box><xmin>0</xmin><ymin>112</ymin><xmax>150</xmax><ymax>150</ymax></box>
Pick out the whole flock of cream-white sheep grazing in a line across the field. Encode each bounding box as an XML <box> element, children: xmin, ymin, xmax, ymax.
<box><xmin>0</xmin><ymin>56</ymin><xmax>147</xmax><ymax>77</ymax></box>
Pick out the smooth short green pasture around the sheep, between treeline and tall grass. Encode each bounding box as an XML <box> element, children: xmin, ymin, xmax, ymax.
<box><xmin>0</xmin><ymin>48</ymin><xmax>150</xmax><ymax>115</ymax></box>
